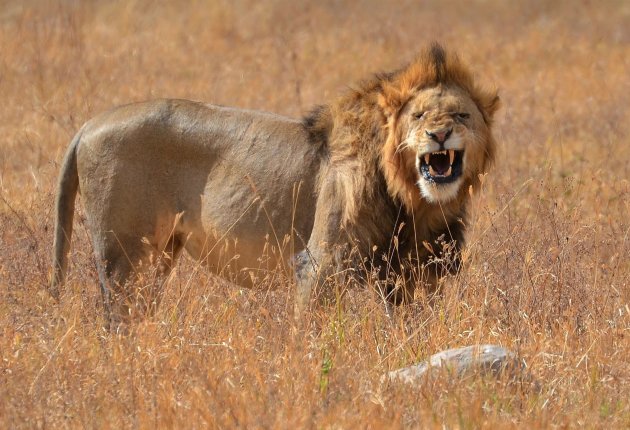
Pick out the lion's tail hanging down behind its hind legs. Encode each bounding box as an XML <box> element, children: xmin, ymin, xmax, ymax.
<box><xmin>50</xmin><ymin>132</ymin><xmax>81</xmax><ymax>299</ymax></box>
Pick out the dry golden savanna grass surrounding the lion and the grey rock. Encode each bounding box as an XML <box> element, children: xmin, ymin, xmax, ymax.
<box><xmin>0</xmin><ymin>0</ymin><xmax>630</xmax><ymax>428</ymax></box>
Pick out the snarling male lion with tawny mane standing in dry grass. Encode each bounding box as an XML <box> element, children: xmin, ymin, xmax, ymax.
<box><xmin>52</xmin><ymin>45</ymin><xmax>499</xmax><ymax>326</ymax></box>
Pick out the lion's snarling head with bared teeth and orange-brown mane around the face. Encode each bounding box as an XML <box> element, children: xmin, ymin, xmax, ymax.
<box><xmin>378</xmin><ymin>45</ymin><xmax>499</xmax><ymax>209</ymax></box>
